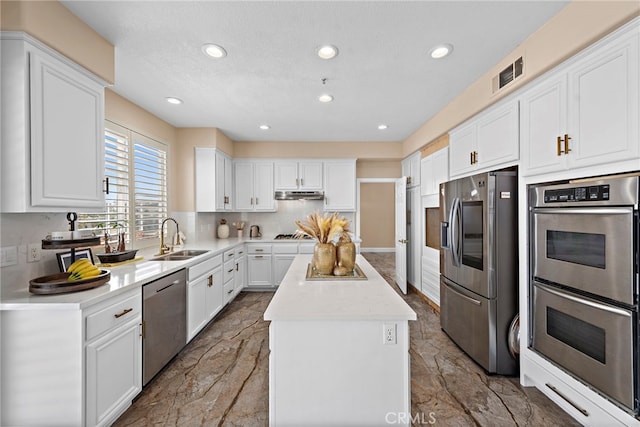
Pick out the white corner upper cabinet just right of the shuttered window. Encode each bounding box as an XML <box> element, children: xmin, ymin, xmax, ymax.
<box><xmin>195</xmin><ymin>147</ymin><xmax>233</xmax><ymax>212</ymax></box>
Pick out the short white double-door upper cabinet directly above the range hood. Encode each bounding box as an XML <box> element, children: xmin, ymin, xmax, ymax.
<box><xmin>274</xmin><ymin>160</ymin><xmax>323</xmax><ymax>190</ymax></box>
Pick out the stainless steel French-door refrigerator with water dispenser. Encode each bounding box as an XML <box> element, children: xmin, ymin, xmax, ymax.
<box><xmin>440</xmin><ymin>170</ymin><xmax>518</xmax><ymax>375</ymax></box>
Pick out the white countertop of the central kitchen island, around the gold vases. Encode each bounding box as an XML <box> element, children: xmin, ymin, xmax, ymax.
<box><xmin>264</xmin><ymin>255</ymin><xmax>416</xmax><ymax>320</ymax></box>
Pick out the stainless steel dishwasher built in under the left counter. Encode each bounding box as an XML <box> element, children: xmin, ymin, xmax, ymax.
<box><xmin>142</xmin><ymin>269</ymin><xmax>187</xmax><ymax>385</ymax></box>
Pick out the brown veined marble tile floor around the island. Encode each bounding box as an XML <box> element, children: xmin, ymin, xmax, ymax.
<box><xmin>114</xmin><ymin>253</ymin><xmax>579</xmax><ymax>427</ymax></box>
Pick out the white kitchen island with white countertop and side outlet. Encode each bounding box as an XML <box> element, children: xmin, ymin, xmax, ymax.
<box><xmin>264</xmin><ymin>255</ymin><xmax>416</xmax><ymax>426</ymax></box>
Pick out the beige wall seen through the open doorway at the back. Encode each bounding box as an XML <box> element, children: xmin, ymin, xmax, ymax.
<box><xmin>360</xmin><ymin>182</ymin><xmax>395</xmax><ymax>250</ymax></box>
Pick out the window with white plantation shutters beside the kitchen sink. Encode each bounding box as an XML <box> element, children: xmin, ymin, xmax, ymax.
<box><xmin>79</xmin><ymin>121</ymin><xmax>168</xmax><ymax>249</ymax></box>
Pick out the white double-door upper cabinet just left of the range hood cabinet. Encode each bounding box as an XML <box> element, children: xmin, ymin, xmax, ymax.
<box><xmin>234</xmin><ymin>161</ymin><xmax>275</xmax><ymax>211</ymax></box>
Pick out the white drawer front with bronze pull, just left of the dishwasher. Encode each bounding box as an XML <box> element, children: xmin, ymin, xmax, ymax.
<box><xmin>86</xmin><ymin>291</ymin><xmax>142</xmax><ymax>341</ymax></box>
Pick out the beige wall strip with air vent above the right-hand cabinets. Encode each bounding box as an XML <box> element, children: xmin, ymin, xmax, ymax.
<box><xmin>403</xmin><ymin>0</ymin><xmax>640</xmax><ymax>157</ymax></box>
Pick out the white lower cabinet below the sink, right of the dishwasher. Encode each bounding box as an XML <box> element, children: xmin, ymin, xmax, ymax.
<box><xmin>187</xmin><ymin>255</ymin><xmax>224</xmax><ymax>341</ymax></box>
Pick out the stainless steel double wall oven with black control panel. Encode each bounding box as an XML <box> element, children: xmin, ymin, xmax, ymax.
<box><xmin>529</xmin><ymin>175</ymin><xmax>640</xmax><ymax>414</ymax></box>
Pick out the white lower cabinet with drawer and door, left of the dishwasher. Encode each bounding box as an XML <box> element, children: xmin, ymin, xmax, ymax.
<box><xmin>85</xmin><ymin>288</ymin><xmax>142</xmax><ymax>426</ymax></box>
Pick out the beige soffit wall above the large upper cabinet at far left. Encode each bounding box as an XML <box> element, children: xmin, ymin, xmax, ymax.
<box><xmin>0</xmin><ymin>0</ymin><xmax>115</xmax><ymax>83</ymax></box>
